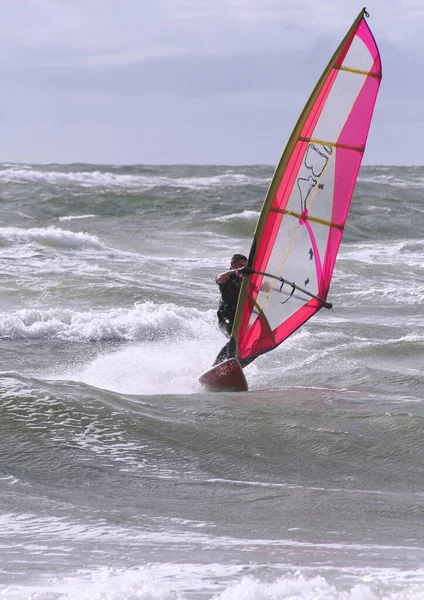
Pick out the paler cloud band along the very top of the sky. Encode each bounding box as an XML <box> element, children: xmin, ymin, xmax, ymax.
<box><xmin>0</xmin><ymin>0</ymin><xmax>424</xmax><ymax>68</ymax></box>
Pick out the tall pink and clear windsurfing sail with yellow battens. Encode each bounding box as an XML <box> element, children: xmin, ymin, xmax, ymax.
<box><xmin>231</xmin><ymin>9</ymin><xmax>381</xmax><ymax>359</ymax></box>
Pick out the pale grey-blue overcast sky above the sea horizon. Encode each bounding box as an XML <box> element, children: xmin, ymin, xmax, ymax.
<box><xmin>0</xmin><ymin>0</ymin><xmax>424</xmax><ymax>165</ymax></box>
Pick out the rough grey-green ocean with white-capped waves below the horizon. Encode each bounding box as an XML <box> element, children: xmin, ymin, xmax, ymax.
<box><xmin>0</xmin><ymin>164</ymin><xmax>424</xmax><ymax>600</ymax></box>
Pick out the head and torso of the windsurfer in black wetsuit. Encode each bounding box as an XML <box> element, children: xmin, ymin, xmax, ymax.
<box><xmin>215</xmin><ymin>254</ymin><xmax>247</xmax><ymax>337</ymax></box>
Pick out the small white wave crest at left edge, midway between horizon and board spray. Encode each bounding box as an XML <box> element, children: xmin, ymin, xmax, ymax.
<box><xmin>0</xmin><ymin>226</ymin><xmax>106</xmax><ymax>249</ymax></box>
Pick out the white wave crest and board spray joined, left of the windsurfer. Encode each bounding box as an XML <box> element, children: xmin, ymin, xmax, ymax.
<box><xmin>0</xmin><ymin>302</ymin><xmax>220</xmax><ymax>394</ymax></box>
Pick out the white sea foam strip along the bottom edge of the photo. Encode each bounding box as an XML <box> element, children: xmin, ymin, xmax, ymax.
<box><xmin>0</xmin><ymin>563</ymin><xmax>424</xmax><ymax>600</ymax></box>
